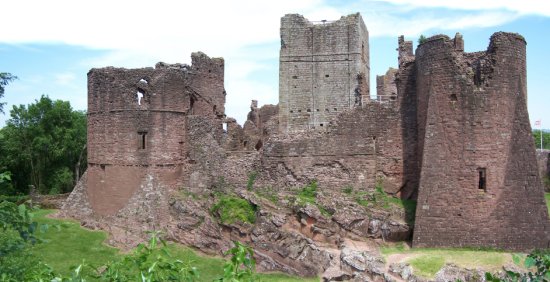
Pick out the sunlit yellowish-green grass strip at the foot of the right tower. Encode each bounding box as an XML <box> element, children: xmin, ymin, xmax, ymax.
<box><xmin>380</xmin><ymin>245</ymin><xmax>513</xmax><ymax>278</ymax></box>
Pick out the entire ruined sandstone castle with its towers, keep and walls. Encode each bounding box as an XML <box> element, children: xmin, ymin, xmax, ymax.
<box><xmin>63</xmin><ymin>11</ymin><xmax>550</xmax><ymax>274</ymax></box>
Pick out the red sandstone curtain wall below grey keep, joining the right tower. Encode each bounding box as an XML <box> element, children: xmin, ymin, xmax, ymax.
<box><xmin>261</xmin><ymin>101</ymin><xmax>410</xmax><ymax>193</ymax></box>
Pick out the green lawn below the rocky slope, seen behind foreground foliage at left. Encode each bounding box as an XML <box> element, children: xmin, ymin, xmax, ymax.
<box><xmin>33</xmin><ymin>210</ymin><xmax>319</xmax><ymax>282</ymax></box>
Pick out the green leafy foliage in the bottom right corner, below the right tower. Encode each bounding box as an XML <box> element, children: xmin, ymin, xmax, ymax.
<box><xmin>485</xmin><ymin>250</ymin><xmax>550</xmax><ymax>282</ymax></box>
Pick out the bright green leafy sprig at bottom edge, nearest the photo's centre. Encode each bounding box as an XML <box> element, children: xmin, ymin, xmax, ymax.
<box><xmin>218</xmin><ymin>241</ymin><xmax>256</xmax><ymax>282</ymax></box>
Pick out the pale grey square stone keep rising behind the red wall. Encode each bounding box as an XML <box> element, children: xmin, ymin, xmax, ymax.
<box><xmin>279</xmin><ymin>14</ymin><xmax>370</xmax><ymax>132</ymax></box>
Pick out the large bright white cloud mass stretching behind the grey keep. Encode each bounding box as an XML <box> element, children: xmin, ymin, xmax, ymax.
<box><xmin>0</xmin><ymin>0</ymin><xmax>550</xmax><ymax>123</ymax></box>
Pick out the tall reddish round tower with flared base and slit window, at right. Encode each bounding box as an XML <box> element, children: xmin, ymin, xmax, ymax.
<box><xmin>413</xmin><ymin>32</ymin><xmax>550</xmax><ymax>251</ymax></box>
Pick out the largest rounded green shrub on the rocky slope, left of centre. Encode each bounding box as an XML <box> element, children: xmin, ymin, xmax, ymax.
<box><xmin>211</xmin><ymin>195</ymin><xmax>257</xmax><ymax>224</ymax></box>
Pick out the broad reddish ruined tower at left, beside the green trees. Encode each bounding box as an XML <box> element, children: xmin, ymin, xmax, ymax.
<box><xmin>75</xmin><ymin>52</ymin><xmax>225</xmax><ymax>215</ymax></box>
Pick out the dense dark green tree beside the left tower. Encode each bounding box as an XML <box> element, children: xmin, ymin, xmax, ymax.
<box><xmin>0</xmin><ymin>96</ymin><xmax>86</xmax><ymax>193</ymax></box>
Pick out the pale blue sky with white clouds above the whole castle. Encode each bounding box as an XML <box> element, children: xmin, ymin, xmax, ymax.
<box><xmin>0</xmin><ymin>0</ymin><xmax>550</xmax><ymax>128</ymax></box>
